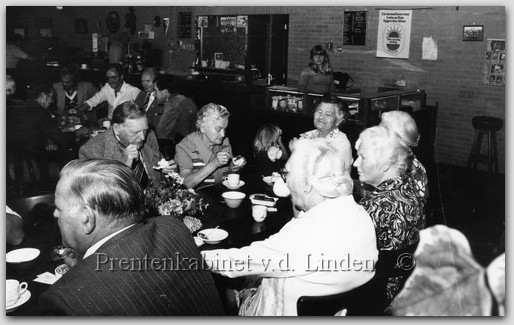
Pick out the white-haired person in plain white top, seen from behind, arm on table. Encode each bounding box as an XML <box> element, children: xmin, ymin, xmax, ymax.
<box><xmin>202</xmin><ymin>139</ymin><xmax>378</xmax><ymax>316</ymax></box>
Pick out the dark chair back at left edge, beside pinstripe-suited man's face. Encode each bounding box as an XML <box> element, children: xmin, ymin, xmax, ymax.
<box><xmin>7</xmin><ymin>194</ymin><xmax>55</xmax><ymax>226</ymax></box>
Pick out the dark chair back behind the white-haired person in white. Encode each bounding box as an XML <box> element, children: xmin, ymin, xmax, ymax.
<box><xmin>296</xmin><ymin>277</ymin><xmax>383</xmax><ymax>316</ymax></box>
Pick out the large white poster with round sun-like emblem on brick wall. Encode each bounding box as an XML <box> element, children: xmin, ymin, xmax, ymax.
<box><xmin>377</xmin><ymin>10</ymin><xmax>412</xmax><ymax>59</ymax></box>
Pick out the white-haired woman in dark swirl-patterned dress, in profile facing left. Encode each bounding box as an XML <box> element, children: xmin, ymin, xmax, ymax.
<box><xmin>353</xmin><ymin>126</ymin><xmax>425</xmax><ymax>313</ymax></box>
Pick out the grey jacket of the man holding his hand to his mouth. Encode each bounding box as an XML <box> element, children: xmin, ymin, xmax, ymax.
<box><xmin>79</xmin><ymin>128</ymin><xmax>163</xmax><ymax>184</ymax></box>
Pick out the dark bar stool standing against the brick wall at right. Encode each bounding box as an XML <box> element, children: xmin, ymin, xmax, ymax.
<box><xmin>466</xmin><ymin>116</ymin><xmax>503</xmax><ymax>179</ymax></box>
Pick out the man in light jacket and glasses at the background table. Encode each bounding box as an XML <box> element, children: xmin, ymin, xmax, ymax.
<box><xmin>79</xmin><ymin>63</ymin><xmax>141</xmax><ymax>118</ymax></box>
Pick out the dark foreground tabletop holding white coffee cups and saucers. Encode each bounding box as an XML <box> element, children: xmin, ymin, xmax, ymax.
<box><xmin>6</xmin><ymin>175</ymin><xmax>293</xmax><ymax>316</ymax></box>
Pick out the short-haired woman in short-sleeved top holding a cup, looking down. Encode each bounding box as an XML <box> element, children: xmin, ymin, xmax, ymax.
<box><xmin>175</xmin><ymin>103</ymin><xmax>246</xmax><ymax>188</ymax></box>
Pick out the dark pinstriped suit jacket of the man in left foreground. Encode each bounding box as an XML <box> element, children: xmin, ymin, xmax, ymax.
<box><xmin>39</xmin><ymin>216</ymin><xmax>223</xmax><ymax>316</ymax></box>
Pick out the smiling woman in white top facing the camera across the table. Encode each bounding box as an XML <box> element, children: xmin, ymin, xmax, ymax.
<box><xmin>289</xmin><ymin>96</ymin><xmax>348</xmax><ymax>151</ymax></box>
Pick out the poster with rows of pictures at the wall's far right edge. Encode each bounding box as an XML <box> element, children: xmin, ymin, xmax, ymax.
<box><xmin>484</xmin><ymin>38</ymin><xmax>506</xmax><ymax>86</ymax></box>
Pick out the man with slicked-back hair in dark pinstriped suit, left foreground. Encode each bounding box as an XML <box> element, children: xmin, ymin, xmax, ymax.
<box><xmin>39</xmin><ymin>159</ymin><xmax>222</xmax><ymax>316</ymax></box>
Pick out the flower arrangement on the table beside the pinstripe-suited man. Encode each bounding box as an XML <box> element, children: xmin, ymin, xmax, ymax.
<box><xmin>145</xmin><ymin>173</ymin><xmax>208</xmax><ymax>233</ymax></box>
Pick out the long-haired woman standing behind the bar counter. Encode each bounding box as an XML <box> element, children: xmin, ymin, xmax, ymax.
<box><xmin>298</xmin><ymin>45</ymin><xmax>335</xmax><ymax>94</ymax></box>
